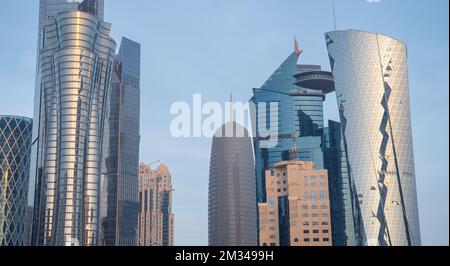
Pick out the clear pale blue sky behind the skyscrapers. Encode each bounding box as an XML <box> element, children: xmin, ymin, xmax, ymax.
<box><xmin>0</xmin><ymin>0</ymin><xmax>449</xmax><ymax>245</ymax></box>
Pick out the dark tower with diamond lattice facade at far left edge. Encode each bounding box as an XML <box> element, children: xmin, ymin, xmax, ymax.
<box><xmin>0</xmin><ymin>115</ymin><xmax>33</xmax><ymax>246</ymax></box>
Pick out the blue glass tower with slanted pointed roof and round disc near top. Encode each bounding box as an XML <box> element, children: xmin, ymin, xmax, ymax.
<box><xmin>250</xmin><ymin>42</ymin><xmax>334</xmax><ymax>202</ymax></box>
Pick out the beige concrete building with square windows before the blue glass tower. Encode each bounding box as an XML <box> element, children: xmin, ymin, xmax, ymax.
<box><xmin>258</xmin><ymin>160</ymin><xmax>332</xmax><ymax>246</ymax></box>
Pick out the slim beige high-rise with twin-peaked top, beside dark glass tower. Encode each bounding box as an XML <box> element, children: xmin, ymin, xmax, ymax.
<box><xmin>139</xmin><ymin>163</ymin><xmax>174</xmax><ymax>246</ymax></box>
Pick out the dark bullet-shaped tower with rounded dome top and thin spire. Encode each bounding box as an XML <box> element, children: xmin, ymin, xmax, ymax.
<box><xmin>208</xmin><ymin>122</ymin><xmax>258</xmax><ymax>246</ymax></box>
